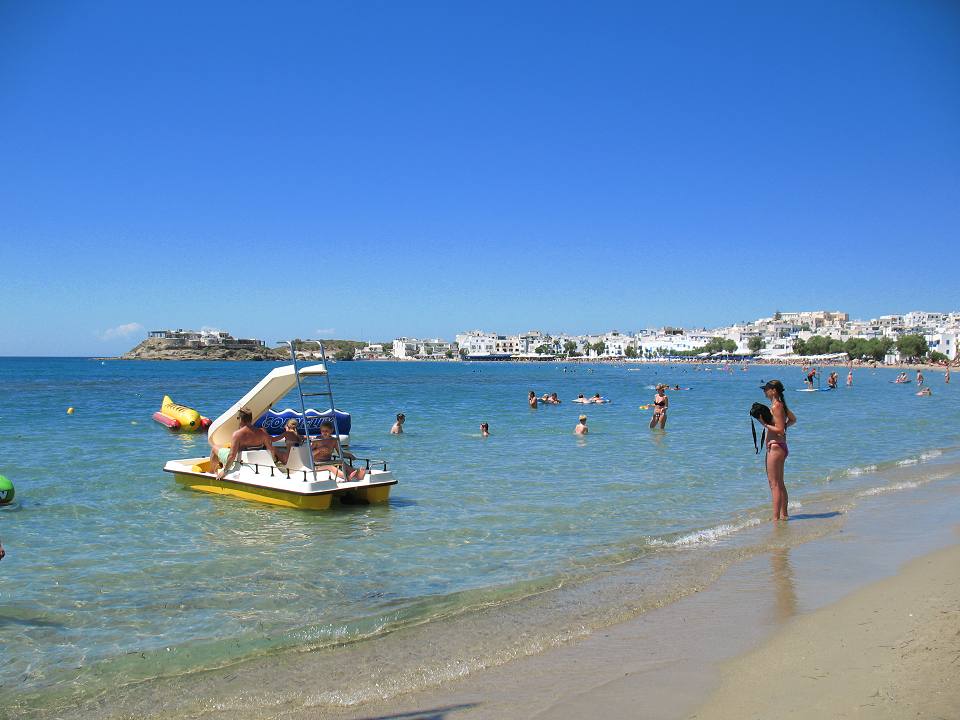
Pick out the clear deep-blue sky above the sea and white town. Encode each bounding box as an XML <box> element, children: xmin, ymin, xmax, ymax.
<box><xmin>0</xmin><ymin>0</ymin><xmax>960</xmax><ymax>355</ymax></box>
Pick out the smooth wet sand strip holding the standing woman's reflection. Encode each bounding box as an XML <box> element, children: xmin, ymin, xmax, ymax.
<box><xmin>316</xmin><ymin>458</ymin><xmax>960</xmax><ymax>720</ymax></box>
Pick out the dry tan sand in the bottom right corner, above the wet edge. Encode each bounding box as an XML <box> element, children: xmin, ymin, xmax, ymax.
<box><xmin>691</xmin><ymin>546</ymin><xmax>960</xmax><ymax>720</ymax></box>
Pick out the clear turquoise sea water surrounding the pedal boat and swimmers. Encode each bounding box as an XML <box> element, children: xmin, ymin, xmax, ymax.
<box><xmin>0</xmin><ymin>358</ymin><xmax>960</xmax><ymax>713</ymax></box>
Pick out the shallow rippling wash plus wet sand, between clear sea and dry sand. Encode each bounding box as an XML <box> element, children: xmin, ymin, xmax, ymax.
<box><xmin>14</xmin><ymin>450</ymin><xmax>960</xmax><ymax>720</ymax></box>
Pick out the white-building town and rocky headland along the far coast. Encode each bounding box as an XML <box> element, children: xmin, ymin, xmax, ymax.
<box><xmin>122</xmin><ymin>310</ymin><xmax>960</xmax><ymax>364</ymax></box>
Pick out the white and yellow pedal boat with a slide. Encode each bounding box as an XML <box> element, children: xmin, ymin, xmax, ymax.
<box><xmin>163</xmin><ymin>364</ymin><xmax>397</xmax><ymax>510</ymax></box>
